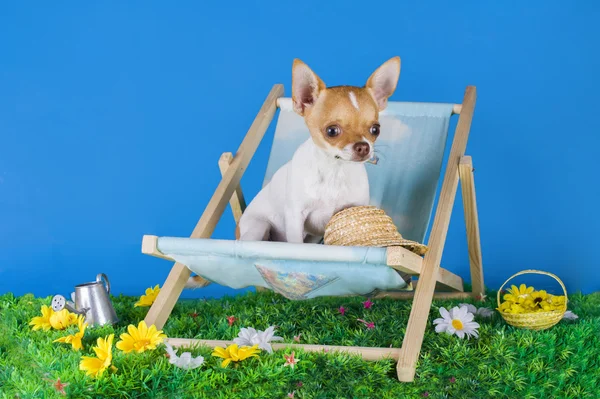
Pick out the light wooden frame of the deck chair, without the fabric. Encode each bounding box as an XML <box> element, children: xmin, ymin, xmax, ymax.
<box><xmin>142</xmin><ymin>84</ymin><xmax>484</xmax><ymax>382</ymax></box>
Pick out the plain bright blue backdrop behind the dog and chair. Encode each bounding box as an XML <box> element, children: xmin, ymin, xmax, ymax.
<box><xmin>0</xmin><ymin>1</ymin><xmax>600</xmax><ymax>297</ymax></box>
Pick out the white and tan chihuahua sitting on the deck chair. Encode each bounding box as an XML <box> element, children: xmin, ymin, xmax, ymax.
<box><xmin>187</xmin><ymin>57</ymin><xmax>400</xmax><ymax>288</ymax></box>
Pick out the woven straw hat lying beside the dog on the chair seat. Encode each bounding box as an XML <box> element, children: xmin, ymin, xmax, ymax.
<box><xmin>324</xmin><ymin>206</ymin><xmax>429</xmax><ymax>255</ymax></box>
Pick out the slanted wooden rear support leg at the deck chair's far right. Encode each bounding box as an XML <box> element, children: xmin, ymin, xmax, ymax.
<box><xmin>459</xmin><ymin>156</ymin><xmax>485</xmax><ymax>297</ymax></box>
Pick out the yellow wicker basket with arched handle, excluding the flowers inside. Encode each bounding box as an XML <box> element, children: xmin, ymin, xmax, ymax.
<box><xmin>497</xmin><ymin>270</ymin><xmax>568</xmax><ymax>330</ymax></box>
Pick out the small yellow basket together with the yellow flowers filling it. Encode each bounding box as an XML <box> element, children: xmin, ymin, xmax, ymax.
<box><xmin>496</xmin><ymin>270</ymin><xmax>567</xmax><ymax>330</ymax></box>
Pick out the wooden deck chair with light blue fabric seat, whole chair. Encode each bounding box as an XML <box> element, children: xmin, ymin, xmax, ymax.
<box><xmin>142</xmin><ymin>85</ymin><xmax>484</xmax><ymax>382</ymax></box>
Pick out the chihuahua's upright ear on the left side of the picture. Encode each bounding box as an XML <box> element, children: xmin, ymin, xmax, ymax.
<box><xmin>292</xmin><ymin>58</ymin><xmax>326</xmax><ymax>116</ymax></box>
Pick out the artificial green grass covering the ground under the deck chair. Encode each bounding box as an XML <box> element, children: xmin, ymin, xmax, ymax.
<box><xmin>0</xmin><ymin>292</ymin><xmax>600</xmax><ymax>399</ymax></box>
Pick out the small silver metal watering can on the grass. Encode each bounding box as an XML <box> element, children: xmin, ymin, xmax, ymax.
<box><xmin>52</xmin><ymin>273</ymin><xmax>119</xmax><ymax>327</ymax></box>
